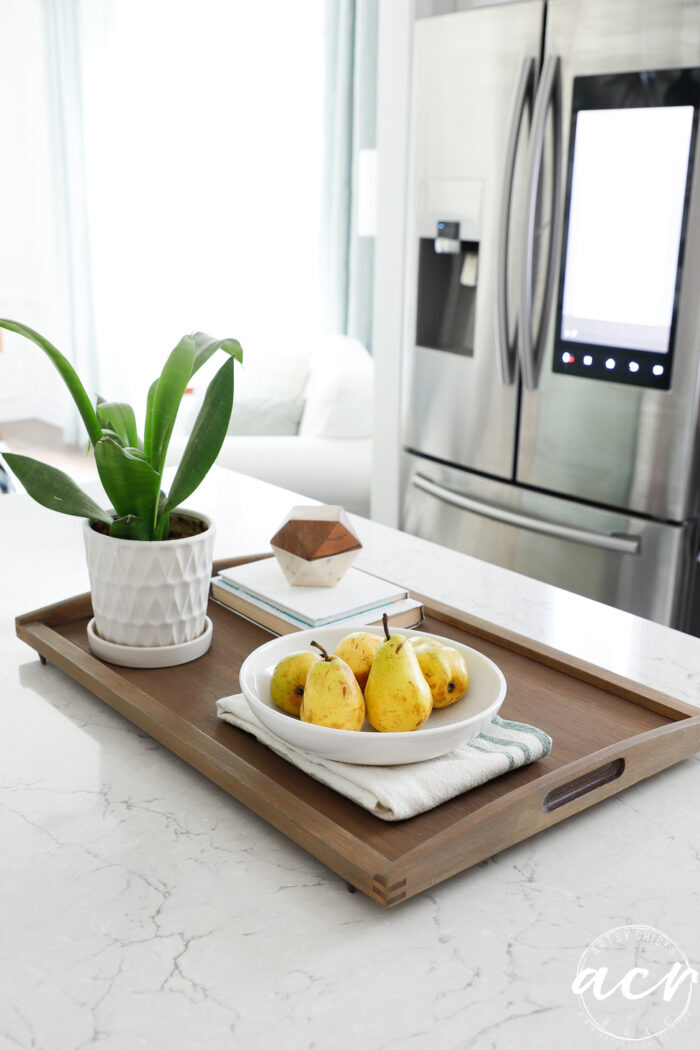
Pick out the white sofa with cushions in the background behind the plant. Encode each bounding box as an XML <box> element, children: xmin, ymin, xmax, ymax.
<box><xmin>168</xmin><ymin>336</ymin><xmax>374</xmax><ymax>517</ymax></box>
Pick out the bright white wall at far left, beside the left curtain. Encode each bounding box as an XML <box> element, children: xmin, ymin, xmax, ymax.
<box><xmin>0</xmin><ymin>0</ymin><xmax>67</xmax><ymax>424</ymax></box>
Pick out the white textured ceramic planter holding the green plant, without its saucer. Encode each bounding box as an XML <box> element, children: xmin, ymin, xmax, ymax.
<box><xmin>83</xmin><ymin>510</ymin><xmax>215</xmax><ymax>647</ymax></box>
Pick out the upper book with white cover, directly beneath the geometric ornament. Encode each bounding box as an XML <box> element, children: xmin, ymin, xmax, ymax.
<box><xmin>219</xmin><ymin>558</ymin><xmax>408</xmax><ymax>627</ymax></box>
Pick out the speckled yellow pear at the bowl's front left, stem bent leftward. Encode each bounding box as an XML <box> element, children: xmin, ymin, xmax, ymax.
<box><xmin>299</xmin><ymin>642</ymin><xmax>364</xmax><ymax>730</ymax></box>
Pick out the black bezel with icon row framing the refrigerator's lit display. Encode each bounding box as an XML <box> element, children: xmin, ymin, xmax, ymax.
<box><xmin>552</xmin><ymin>67</ymin><xmax>700</xmax><ymax>390</ymax></box>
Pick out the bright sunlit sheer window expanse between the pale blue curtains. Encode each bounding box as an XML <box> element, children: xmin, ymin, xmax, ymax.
<box><xmin>59</xmin><ymin>0</ymin><xmax>324</xmax><ymax>416</ymax></box>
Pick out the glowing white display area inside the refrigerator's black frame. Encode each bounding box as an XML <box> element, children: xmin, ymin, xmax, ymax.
<box><xmin>560</xmin><ymin>106</ymin><xmax>694</xmax><ymax>353</ymax></box>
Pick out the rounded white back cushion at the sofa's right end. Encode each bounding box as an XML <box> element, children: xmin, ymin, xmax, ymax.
<box><xmin>299</xmin><ymin>335</ymin><xmax>375</xmax><ymax>438</ymax></box>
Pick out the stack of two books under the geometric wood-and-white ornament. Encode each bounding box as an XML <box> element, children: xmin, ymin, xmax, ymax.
<box><xmin>211</xmin><ymin>558</ymin><xmax>423</xmax><ymax>634</ymax></box>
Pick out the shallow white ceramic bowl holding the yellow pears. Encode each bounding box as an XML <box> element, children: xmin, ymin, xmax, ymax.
<box><xmin>240</xmin><ymin>626</ymin><xmax>506</xmax><ymax>765</ymax></box>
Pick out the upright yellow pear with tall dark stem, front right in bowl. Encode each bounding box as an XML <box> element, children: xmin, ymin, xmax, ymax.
<box><xmin>364</xmin><ymin>613</ymin><xmax>432</xmax><ymax>733</ymax></box>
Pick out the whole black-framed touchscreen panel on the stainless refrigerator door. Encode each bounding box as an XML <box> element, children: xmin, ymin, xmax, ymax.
<box><xmin>554</xmin><ymin>70</ymin><xmax>698</xmax><ymax>387</ymax></box>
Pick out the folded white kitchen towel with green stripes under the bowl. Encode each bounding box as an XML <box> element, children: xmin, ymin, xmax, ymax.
<box><xmin>216</xmin><ymin>694</ymin><xmax>552</xmax><ymax>820</ymax></box>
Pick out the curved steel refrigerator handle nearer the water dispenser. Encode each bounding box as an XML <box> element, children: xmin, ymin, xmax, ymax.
<box><xmin>495</xmin><ymin>56</ymin><xmax>536</xmax><ymax>386</ymax></box>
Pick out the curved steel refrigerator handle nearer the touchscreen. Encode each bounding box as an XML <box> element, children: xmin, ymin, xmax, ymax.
<box><xmin>518</xmin><ymin>55</ymin><xmax>563</xmax><ymax>390</ymax></box>
